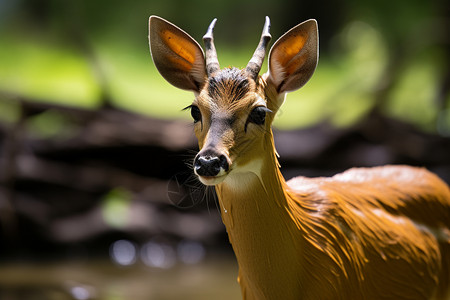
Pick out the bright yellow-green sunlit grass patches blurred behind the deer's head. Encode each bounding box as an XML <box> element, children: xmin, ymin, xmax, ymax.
<box><xmin>0</xmin><ymin>22</ymin><xmax>442</xmax><ymax>129</ymax></box>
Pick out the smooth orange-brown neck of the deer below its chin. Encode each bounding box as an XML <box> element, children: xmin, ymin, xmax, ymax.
<box><xmin>216</xmin><ymin>132</ymin><xmax>302</xmax><ymax>299</ymax></box>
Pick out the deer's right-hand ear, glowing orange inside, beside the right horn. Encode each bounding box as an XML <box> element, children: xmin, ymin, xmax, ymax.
<box><xmin>269</xmin><ymin>20</ymin><xmax>319</xmax><ymax>94</ymax></box>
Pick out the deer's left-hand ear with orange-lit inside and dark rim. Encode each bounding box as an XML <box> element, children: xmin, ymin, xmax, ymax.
<box><xmin>149</xmin><ymin>16</ymin><xmax>206</xmax><ymax>92</ymax></box>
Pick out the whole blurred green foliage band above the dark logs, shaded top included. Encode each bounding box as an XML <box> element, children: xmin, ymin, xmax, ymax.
<box><xmin>0</xmin><ymin>0</ymin><xmax>450</xmax><ymax>130</ymax></box>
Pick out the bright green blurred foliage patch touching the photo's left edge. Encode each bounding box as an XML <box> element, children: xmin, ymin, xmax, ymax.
<box><xmin>0</xmin><ymin>34</ymin><xmax>100</xmax><ymax>107</ymax></box>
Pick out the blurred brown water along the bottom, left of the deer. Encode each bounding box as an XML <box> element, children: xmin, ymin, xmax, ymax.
<box><xmin>0</xmin><ymin>255</ymin><xmax>240</xmax><ymax>300</ymax></box>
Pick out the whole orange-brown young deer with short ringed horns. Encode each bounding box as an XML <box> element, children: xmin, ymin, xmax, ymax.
<box><xmin>149</xmin><ymin>16</ymin><xmax>450</xmax><ymax>300</ymax></box>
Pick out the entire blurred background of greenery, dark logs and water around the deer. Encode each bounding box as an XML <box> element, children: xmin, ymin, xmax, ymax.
<box><xmin>0</xmin><ymin>0</ymin><xmax>450</xmax><ymax>300</ymax></box>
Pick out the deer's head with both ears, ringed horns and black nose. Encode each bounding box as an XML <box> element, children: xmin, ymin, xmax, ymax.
<box><xmin>149</xmin><ymin>16</ymin><xmax>318</xmax><ymax>185</ymax></box>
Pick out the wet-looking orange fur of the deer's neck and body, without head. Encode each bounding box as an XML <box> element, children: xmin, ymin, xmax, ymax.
<box><xmin>216</xmin><ymin>125</ymin><xmax>450</xmax><ymax>300</ymax></box>
